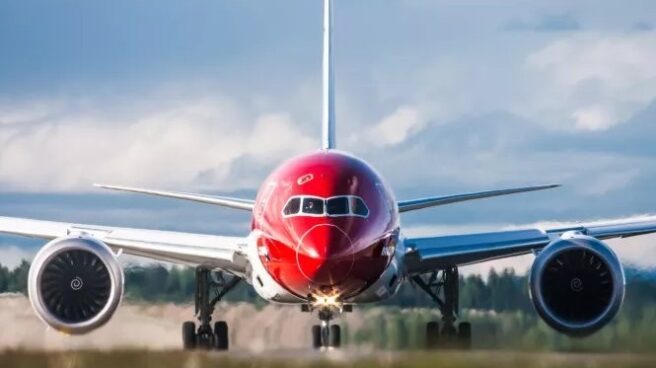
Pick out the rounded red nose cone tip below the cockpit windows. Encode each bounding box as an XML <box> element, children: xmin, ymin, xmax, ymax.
<box><xmin>296</xmin><ymin>224</ymin><xmax>354</xmax><ymax>286</ymax></box>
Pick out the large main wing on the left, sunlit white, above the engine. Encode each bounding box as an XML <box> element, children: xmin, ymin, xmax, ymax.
<box><xmin>0</xmin><ymin>217</ymin><xmax>247</xmax><ymax>274</ymax></box>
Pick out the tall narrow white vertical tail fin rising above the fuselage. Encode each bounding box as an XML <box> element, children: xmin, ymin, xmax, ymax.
<box><xmin>322</xmin><ymin>0</ymin><xmax>335</xmax><ymax>149</ymax></box>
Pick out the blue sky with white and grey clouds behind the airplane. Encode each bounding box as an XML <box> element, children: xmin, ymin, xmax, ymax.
<box><xmin>0</xmin><ymin>0</ymin><xmax>656</xmax><ymax>270</ymax></box>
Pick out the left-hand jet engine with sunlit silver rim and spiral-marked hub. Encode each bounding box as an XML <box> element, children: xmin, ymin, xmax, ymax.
<box><xmin>28</xmin><ymin>236</ymin><xmax>123</xmax><ymax>334</ymax></box>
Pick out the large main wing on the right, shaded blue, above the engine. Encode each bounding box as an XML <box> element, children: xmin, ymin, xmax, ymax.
<box><xmin>406</xmin><ymin>216</ymin><xmax>656</xmax><ymax>274</ymax></box>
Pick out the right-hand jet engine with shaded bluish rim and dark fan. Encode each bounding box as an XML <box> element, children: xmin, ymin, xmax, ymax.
<box><xmin>529</xmin><ymin>232</ymin><xmax>625</xmax><ymax>337</ymax></box>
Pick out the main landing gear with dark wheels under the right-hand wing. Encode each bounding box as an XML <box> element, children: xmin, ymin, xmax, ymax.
<box><xmin>412</xmin><ymin>267</ymin><xmax>471</xmax><ymax>349</ymax></box>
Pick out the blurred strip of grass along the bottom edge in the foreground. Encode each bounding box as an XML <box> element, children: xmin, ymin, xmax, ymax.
<box><xmin>0</xmin><ymin>350</ymin><xmax>656</xmax><ymax>368</ymax></box>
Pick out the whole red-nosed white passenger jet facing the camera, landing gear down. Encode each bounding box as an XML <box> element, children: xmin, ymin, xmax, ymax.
<box><xmin>0</xmin><ymin>0</ymin><xmax>656</xmax><ymax>350</ymax></box>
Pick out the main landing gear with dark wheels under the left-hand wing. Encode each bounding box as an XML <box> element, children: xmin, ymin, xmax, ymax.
<box><xmin>182</xmin><ymin>267</ymin><xmax>241</xmax><ymax>350</ymax></box>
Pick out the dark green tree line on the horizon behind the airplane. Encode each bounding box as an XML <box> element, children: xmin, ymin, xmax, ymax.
<box><xmin>0</xmin><ymin>261</ymin><xmax>656</xmax><ymax>314</ymax></box>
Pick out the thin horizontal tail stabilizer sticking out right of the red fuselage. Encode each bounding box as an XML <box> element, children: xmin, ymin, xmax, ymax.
<box><xmin>398</xmin><ymin>184</ymin><xmax>560</xmax><ymax>212</ymax></box>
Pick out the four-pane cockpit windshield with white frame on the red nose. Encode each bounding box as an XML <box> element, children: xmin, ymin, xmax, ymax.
<box><xmin>282</xmin><ymin>195</ymin><xmax>369</xmax><ymax>217</ymax></box>
